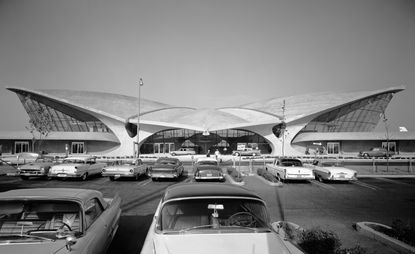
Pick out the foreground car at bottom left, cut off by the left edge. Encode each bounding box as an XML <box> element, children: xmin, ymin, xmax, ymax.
<box><xmin>0</xmin><ymin>188</ymin><xmax>121</xmax><ymax>254</ymax></box>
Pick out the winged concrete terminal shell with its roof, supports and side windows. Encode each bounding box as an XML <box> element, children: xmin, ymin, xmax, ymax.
<box><xmin>0</xmin><ymin>87</ymin><xmax>413</xmax><ymax>156</ymax></box>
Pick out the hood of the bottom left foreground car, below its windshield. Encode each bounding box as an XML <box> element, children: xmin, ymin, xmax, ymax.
<box><xmin>0</xmin><ymin>240</ymin><xmax>69</xmax><ymax>254</ymax></box>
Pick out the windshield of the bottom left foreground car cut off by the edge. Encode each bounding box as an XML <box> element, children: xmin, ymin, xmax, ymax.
<box><xmin>0</xmin><ymin>200</ymin><xmax>81</xmax><ymax>243</ymax></box>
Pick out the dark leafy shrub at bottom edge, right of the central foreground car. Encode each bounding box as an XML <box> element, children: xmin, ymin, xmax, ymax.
<box><xmin>298</xmin><ymin>228</ymin><xmax>341</xmax><ymax>254</ymax></box>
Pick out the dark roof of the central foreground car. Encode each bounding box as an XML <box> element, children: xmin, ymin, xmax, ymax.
<box><xmin>163</xmin><ymin>183</ymin><xmax>262</xmax><ymax>201</ymax></box>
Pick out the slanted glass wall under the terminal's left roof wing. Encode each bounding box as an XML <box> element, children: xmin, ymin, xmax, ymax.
<box><xmin>19</xmin><ymin>96</ymin><xmax>111</xmax><ymax>133</ymax></box>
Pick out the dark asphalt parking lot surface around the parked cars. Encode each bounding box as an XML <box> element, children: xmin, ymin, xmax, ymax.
<box><xmin>0</xmin><ymin>165</ymin><xmax>415</xmax><ymax>253</ymax></box>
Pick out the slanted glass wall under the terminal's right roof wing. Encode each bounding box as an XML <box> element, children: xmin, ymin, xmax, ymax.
<box><xmin>302</xmin><ymin>93</ymin><xmax>393</xmax><ymax>132</ymax></box>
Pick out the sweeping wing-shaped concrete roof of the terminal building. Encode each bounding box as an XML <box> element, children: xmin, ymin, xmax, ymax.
<box><xmin>8</xmin><ymin>86</ymin><xmax>405</xmax><ymax>131</ymax></box>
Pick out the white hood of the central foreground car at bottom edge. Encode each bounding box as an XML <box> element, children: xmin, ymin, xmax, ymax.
<box><xmin>153</xmin><ymin>233</ymin><xmax>290</xmax><ymax>254</ymax></box>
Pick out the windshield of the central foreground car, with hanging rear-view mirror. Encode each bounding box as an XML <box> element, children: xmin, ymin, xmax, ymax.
<box><xmin>158</xmin><ymin>198</ymin><xmax>269</xmax><ymax>234</ymax></box>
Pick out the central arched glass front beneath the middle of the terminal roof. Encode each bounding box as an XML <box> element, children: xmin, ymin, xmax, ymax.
<box><xmin>140</xmin><ymin>129</ymin><xmax>271</xmax><ymax>154</ymax></box>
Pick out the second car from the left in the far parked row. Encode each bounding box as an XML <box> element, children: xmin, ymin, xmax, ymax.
<box><xmin>17</xmin><ymin>157</ymin><xmax>57</xmax><ymax>180</ymax></box>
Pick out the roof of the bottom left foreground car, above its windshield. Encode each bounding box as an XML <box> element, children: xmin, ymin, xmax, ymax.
<box><xmin>0</xmin><ymin>188</ymin><xmax>102</xmax><ymax>203</ymax></box>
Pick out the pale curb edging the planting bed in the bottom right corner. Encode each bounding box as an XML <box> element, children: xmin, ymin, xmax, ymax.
<box><xmin>356</xmin><ymin>221</ymin><xmax>415</xmax><ymax>253</ymax></box>
